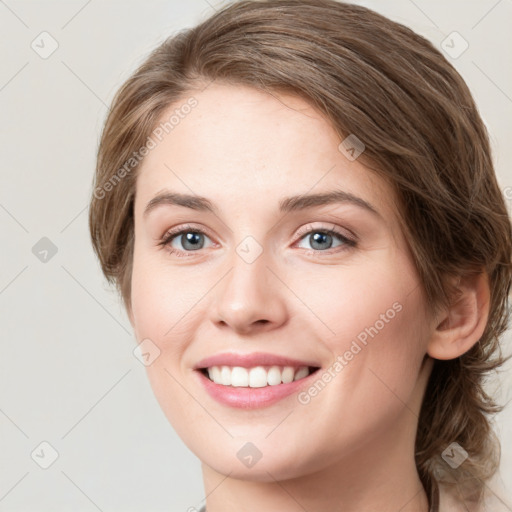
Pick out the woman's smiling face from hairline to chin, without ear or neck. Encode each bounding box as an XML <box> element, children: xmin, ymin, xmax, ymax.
<box><xmin>131</xmin><ymin>84</ymin><xmax>430</xmax><ymax>481</ymax></box>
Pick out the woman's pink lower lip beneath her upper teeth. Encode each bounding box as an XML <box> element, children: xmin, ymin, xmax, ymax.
<box><xmin>196</xmin><ymin>370</ymin><xmax>318</xmax><ymax>409</ymax></box>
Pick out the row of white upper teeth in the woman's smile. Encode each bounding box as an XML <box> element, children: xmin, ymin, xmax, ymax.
<box><xmin>208</xmin><ymin>366</ymin><xmax>309</xmax><ymax>388</ymax></box>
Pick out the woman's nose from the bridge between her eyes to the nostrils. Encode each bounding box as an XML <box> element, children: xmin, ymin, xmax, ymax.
<box><xmin>213</xmin><ymin>236</ymin><xmax>286</xmax><ymax>332</ymax></box>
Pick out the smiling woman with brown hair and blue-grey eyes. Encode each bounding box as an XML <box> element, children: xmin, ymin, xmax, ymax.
<box><xmin>90</xmin><ymin>0</ymin><xmax>512</xmax><ymax>512</ymax></box>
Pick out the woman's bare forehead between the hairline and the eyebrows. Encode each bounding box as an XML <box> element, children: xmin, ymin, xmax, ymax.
<box><xmin>136</xmin><ymin>84</ymin><xmax>393</xmax><ymax>220</ymax></box>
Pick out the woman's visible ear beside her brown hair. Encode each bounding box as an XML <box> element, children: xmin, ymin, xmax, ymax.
<box><xmin>427</xmin><ymin>271</ymin><xmax>490</xmax><ymax>359</ymax></box>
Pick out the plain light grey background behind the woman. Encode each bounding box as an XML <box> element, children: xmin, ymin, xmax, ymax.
<box><xmin>0</xmin><ymin>0</ymin><xmax>512</xmax><ymax>512</ymax></box>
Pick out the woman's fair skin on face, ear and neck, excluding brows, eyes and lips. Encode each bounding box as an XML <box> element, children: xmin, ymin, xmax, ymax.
<box><xmin>126</xmin><ymin>83</ymin><xmax>488</xmax><ymax>512</ymax></box>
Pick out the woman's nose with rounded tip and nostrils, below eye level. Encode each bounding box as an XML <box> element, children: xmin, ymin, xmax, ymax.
<box><xmin>212</xmin><ymin>247</ymin><xmax>289</xmax><ymax>334</ymax></box>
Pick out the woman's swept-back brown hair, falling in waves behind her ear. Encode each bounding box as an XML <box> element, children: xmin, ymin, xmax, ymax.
<box><xmin>89</xmin><ymin>0</ymin><xmax>512</xmax><ymax>501</ymax></box>
